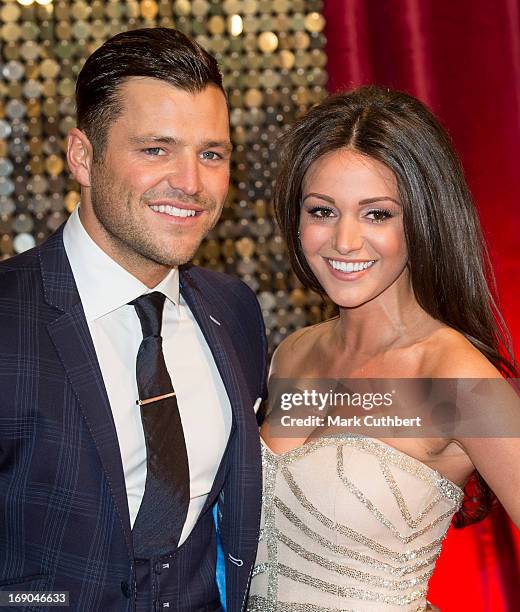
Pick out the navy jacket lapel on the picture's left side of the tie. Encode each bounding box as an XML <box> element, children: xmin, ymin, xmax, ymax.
<box><xmin>40</xmin><ymin>228</ymin><xmax>133</xmax><ymax>556</ymax></box>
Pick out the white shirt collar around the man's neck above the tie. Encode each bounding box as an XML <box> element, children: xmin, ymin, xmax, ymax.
<box><xmin>63</xmin><ymin>206</ymin><xmax>179</xmax><ymax>322</ymax></box>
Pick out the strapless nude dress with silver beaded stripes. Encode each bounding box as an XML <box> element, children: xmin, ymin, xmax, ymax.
<box><xmin>247</xmin><ymin>436</ymin><xmax>463</xmax><ymax>612</ymax></box>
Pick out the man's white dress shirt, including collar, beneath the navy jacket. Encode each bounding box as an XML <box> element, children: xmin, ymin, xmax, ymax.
<box><xmin>63</xmin><ymin>207</ymin><xmax>231</xmax><ymax>545</ymax></box>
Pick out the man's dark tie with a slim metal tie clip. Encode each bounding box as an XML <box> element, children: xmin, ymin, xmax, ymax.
<box><xmin>130</xmin><ymin>291</ymin><xmax>190</xmax><ymax>558</ymax></box>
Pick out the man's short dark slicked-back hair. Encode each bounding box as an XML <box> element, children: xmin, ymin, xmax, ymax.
<box><xmin>76</xmin><ymin>28</ymin><xmax>223</xmax><ymax>156</ymax></box>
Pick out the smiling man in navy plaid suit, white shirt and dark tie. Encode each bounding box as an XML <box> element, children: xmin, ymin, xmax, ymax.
<box><xmin>0</xmin><ymin>28</ymin><xmax>266</xmax><ymax>612</ymax></box>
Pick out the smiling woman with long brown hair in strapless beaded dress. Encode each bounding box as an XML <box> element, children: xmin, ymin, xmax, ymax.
<box><xmin>248</xmin><ymin>87</ymin><xmax>520</xmax><ymax>612</ymax></box>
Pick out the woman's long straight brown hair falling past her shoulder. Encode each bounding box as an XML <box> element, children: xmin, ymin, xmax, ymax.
<box><xmin>274</xmin><ymin>86</ymin><xmax>517</xmax><ymax>527</ymax></box>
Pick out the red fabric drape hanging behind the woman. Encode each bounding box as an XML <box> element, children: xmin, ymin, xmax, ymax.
<box><xmin>324</xmin><ymin>0</ymin><xmax>520</xmax><ymax>612</ymax></box>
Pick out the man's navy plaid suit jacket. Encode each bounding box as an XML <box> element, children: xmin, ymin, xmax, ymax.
<box><xmin>0</xmin><ymin>228</ymin><xmax>267</xmax><ymax>612</ymax></box>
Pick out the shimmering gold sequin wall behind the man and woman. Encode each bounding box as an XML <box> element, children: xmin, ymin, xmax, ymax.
<box><xmin>0</xmin><ymin>0</ymin><xmax>327</xmax><ymax>348</ymax></box>
